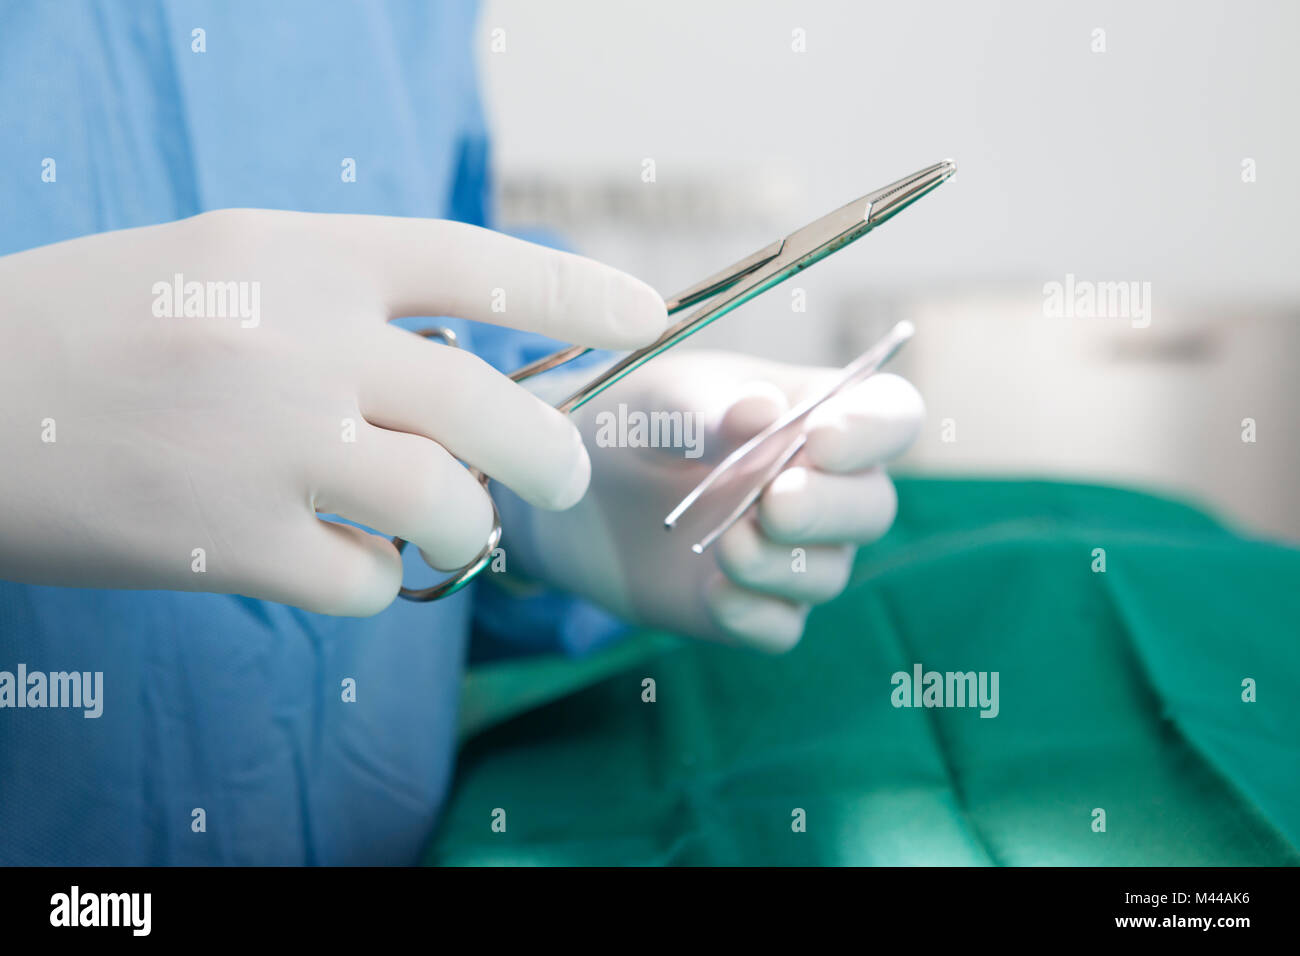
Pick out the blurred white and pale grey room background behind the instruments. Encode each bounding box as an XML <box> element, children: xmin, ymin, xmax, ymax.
<box><xmin>480</xmin><ymin>0</ymin><xmax>1300</xmax><ymax>540</ymax></box>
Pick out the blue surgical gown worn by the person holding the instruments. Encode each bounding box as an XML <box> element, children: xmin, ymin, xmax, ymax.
<box><xmin>0</xmin><ymin>0</ymin><xmax>608</xmax><ymax>865</ymax></box>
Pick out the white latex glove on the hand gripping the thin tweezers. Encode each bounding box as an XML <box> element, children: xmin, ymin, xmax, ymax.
<box><xmin>498</xmin><ymin>351</ymin><xmax>924</xmax><ymax>652</ymax></box>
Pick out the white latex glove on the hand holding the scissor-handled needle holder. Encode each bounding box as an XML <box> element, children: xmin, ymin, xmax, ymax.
<box><xmin>0</xmin><ymin>209</ymin><xmax>667</xmax><ymax>615</ymax></box>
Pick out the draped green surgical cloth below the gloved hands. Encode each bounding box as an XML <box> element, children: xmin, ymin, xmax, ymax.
<box><xmin>426</xmin><ymin>480</ymin><xmax>1300</xmax><ymax>865</ymax></box>
